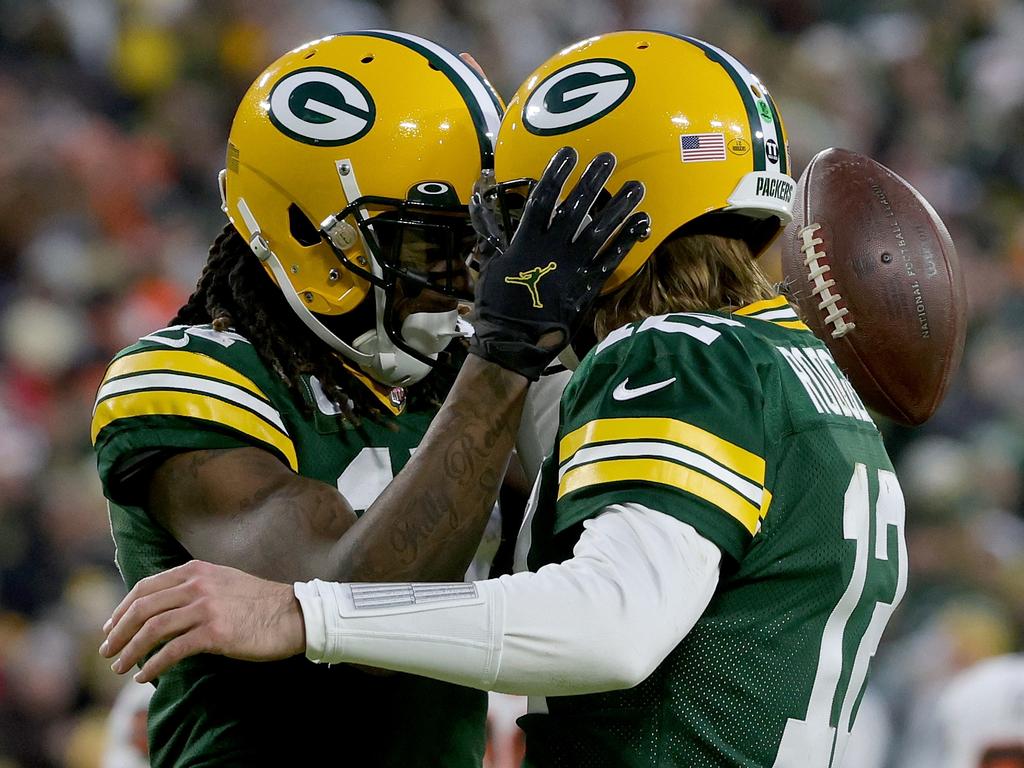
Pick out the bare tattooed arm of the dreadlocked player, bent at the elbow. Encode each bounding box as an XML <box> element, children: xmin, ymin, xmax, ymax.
<box><xmin>148</xmin><ymin>357</ymin><xmax>526</xmax><ymax>582</ymax></box>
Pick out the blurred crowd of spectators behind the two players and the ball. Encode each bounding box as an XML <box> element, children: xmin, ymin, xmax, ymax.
<box><xmin>0</xmin><ymin>0</ymin><xmax>1024</xmax><ymax>768</ymax></box>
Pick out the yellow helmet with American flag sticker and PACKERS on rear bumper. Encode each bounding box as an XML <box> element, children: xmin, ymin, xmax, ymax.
<box><xmin>493</xmin><ymin>31</ymin><xmax>796</xmax><ymax>293</ymax></box>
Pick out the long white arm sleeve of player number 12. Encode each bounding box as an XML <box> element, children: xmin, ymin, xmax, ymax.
<box><xmin>295</xmin><ymin>504</ymin><xmax>721</xmax><ymax>695</ymax></box>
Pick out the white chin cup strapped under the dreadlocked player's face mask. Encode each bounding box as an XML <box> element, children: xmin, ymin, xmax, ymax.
<box><xmin>353</xmin><ymin>309</ymin><xmax>463</xmax><ymax>386</ymax></box>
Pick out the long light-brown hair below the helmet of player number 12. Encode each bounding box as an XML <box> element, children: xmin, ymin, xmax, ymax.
<box><xmin>594</xmin><ymin>233</ymin><xmax>777</xmax><ymax>339</ymax></box>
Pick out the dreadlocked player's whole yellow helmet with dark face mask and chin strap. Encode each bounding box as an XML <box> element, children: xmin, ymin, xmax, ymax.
<box><xmin>220</xmin><ymin>31</ymin><xmax>502</xmax><ymax>385</ymax></box>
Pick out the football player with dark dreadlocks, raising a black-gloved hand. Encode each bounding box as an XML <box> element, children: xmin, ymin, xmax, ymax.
<box><xmin>92</xmin><ymin>31</ymin><xmax>644</xmax><ymax>766</ymax></box>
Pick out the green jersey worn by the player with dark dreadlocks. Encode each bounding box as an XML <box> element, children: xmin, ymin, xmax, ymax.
<box><xmin>92</xmin><ymin>326</ymin><xmax>486</xmax><ymax>768</ymax></box>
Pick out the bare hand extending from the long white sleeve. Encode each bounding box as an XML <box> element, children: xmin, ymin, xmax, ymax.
<box><xmin>99</xmin><ymin>560</ymin><xmax>306</xmax><ymax>683</ymax></box>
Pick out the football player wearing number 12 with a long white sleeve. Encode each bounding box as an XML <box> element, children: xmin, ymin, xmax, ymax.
<box><xmin>105</xmin><ymin>32</ymin><xmax>907</xmax><ymax>768</ymax></box>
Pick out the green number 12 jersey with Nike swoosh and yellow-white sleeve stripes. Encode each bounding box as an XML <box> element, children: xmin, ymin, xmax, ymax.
<box><xmin>520</xmin><ymin>297</ymin><xmax>906</xmax><ymax>768</ymax></box>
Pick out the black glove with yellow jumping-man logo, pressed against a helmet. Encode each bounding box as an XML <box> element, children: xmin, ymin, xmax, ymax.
<box><xmin>469</xmin><ymin>146</ymin><xmax>650</xmax><ymax>381</ymax></box>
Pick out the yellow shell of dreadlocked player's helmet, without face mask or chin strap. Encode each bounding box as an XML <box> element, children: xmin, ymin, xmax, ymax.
<box><xmin>222</xmin><ymin>31</ymin><xmax>502</xmax><ymax>314</ymax></box>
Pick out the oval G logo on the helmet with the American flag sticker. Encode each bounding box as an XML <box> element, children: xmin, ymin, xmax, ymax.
<box><xmin>522</xmin><ymin>58</ymin><xmax>637</xmax><ymax>136</ymax></box>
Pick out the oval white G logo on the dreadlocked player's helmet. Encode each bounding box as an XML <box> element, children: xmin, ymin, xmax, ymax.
<box><xmin>267</xmin><ymin>67</ymin><xmax>377</xmax><ymax>146</ymax></box>
